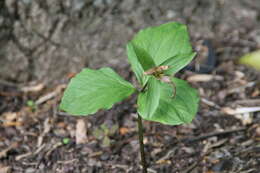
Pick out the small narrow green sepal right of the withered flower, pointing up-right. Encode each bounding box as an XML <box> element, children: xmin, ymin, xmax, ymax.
<box><xmin>161</xmin><ymin>52</ymin><xmax>196</xmax><ymax>75</ymax></box>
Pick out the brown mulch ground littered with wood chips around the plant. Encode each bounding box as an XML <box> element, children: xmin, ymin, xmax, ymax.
<box><xmin>0</xmin><ymin>55</ymin><xmax>260</xmax><ymax>173</ymax></box>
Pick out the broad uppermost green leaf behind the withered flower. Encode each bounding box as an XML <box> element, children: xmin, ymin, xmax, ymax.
<box><xmin>131</xmin><ymin>22</ymin><xmax>192</xmax><ymax>68</ymax></box>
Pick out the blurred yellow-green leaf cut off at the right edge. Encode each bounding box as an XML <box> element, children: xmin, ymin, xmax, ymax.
<box><xmin>239</xmin><ymin>50</ymin><xmax>260</xmax><ymax>70</ymax></box>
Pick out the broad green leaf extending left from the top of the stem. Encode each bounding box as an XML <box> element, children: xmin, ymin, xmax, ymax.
<box><xmin>60</xmin><ymin>68</ymin><xmax>135</xmax><ymax>115</ymax></box>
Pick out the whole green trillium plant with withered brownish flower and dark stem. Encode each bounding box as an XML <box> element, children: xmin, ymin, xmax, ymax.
<box><xmin>60</xmin><ymin>22</ymin><xmax>199</xmax><ymax>173</ymax></box>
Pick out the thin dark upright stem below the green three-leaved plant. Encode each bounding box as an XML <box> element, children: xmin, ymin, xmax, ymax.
<box><xmin>138</xmin><ymin>114</ymin><xmax>147</xmax><ymax>173</ymax></box>
